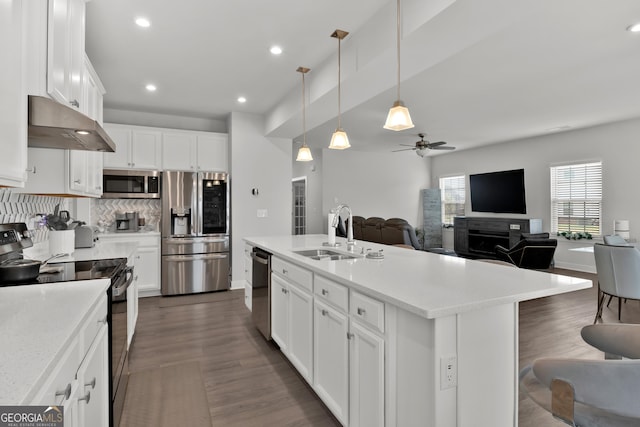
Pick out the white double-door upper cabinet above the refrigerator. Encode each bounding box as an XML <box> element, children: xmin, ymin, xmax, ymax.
<box><xmin>162</xmin><ymin>131</ymin><xmax>228</xmax><ymax>172</ymax></box>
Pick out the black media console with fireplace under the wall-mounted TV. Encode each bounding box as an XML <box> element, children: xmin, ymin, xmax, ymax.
<box><xmin>453</xmin><ymin>217</ymin><xmax>542</xmax><ymax>258</ymax></box>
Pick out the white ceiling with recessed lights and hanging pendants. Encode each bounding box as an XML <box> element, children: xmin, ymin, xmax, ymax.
<box><xmin>86</xmin><ymin>0</ymin><xmax>640</xmax><ymax>155</ymax></box>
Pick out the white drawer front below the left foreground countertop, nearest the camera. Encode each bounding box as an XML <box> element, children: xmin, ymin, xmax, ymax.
<box><xmin>30</xmin><ymin>339</ymin><xmax>81</xmax><ymax>405</ymax></box>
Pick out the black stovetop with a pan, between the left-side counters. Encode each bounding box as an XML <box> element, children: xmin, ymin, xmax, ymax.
<box><xmin>2</xmin><ymin>258</ymin><xmax>127</xmax><ymax>286</ymax></box>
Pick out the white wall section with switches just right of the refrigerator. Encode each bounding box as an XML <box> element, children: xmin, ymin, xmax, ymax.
<box><xmin>228</xmin><ymin>113</ymin><xmax>293</xmax><ymax>288</ymax></box>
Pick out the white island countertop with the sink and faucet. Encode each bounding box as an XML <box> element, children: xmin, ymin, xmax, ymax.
<box><xmin>244</xmin><ymin>235</ymin><xmax>593</xmax><ymax>318</ymax></box>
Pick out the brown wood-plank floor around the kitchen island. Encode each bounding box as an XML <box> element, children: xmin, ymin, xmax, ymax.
<box><xmin>121</xmin><ymin>270</ymin><xmax>640</xmax><ymax>427</ymax></box>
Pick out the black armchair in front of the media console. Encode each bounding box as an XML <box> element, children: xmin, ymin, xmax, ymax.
<box><xmin>495</xmin><ymin>238</ymin><xmax>558</xmax><ymax>270</ymax></box>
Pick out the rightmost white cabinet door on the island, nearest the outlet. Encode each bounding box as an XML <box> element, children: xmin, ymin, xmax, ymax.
<box><xmin>349</xmin><ymin>322</ymin><xmax>385</xmax><ymax>427</ymax></box>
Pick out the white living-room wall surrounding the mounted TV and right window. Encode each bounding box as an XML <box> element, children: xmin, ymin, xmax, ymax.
<box><xmin>431</xmin><ymin>119</ymin><xmax>640</xmax><ymax>272</ymax></box>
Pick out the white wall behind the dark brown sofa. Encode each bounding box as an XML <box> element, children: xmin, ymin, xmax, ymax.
<box><xmin>322</xmin><ymin>149</ymin><xmax>431</xmax><ymax>233</ymax></box>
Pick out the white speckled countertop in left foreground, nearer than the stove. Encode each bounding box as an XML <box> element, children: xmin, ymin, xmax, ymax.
<box><xmin>0</xmin><ymin>279</ymin><xmax>110</xmax><ymax>405</ymax></box>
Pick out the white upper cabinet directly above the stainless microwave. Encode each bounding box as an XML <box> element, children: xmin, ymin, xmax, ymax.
<box><xmin>104</xmin><ymin>123</ymin><xmax>162</xmax><ymax>170</ymax></box>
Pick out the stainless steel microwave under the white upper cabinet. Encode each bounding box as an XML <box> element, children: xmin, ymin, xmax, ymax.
<box><xmin>102</xmin><ymin>169</ymin><xmax>161</xmax><ymax>199</ymax></box>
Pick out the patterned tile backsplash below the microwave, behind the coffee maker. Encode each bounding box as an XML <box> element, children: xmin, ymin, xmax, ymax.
<box><xmin>91</xmin><ymin>199</ymin><xmax>162</xmax><ymax>231</ymax></box>
